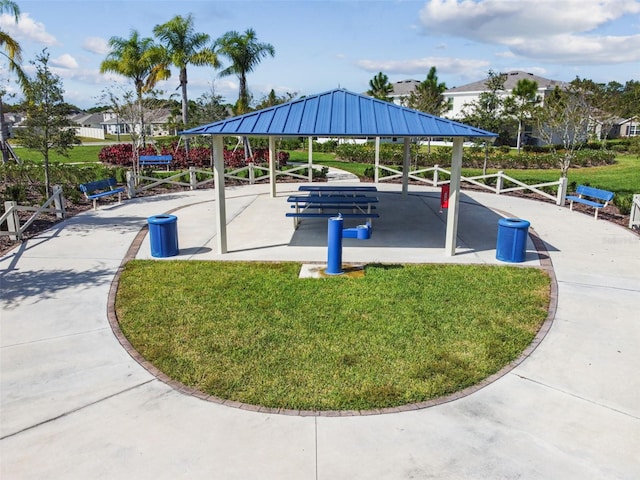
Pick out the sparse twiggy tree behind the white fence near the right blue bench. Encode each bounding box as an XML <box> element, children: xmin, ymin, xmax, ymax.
<box><xmin>538</xmin><ymin>80</ymin><xmax>593</xmax><ymax>177</ymax></box>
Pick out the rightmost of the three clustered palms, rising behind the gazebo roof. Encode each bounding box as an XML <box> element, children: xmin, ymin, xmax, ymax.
<box><xmin>216</xmin><ymin>28</ymin><xmax>275</xmax><ymax>114</ymax></box>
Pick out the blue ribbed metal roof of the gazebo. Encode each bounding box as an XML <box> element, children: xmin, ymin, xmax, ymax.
<box><xmin>179</xmin><ymin>89</ymin><xmax>497</xmax><ymax>137</ymax></box>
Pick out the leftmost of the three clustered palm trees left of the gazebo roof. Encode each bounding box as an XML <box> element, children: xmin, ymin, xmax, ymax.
<box><xmin>100</xmin><ymin>30</ymin><xmax>171</xmax><ymax>144</ymax></box>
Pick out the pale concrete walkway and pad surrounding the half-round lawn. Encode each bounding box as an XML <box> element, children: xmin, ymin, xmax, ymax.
<box><xmin>0</xmin><ymin>185</ymin><xmax>640</xmax><ymax>480</ymax></box>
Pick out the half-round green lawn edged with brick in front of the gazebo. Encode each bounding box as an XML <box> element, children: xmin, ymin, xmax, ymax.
<box><xmin>116</xmin><ymin>260</ymin><xmax>550</xmax><ymax>410</ymax></box>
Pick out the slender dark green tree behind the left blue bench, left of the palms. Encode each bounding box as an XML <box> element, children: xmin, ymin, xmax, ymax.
<box><xmin>17</xmin><ymin>50</ymin><xmax>80</xmax><ymax>198</ymax></box>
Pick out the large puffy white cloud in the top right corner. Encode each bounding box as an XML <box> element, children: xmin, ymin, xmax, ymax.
<box><xmin>420</xmin><ymin>0</ymin><xmax>640</xmax><ymax>65</ymax></box>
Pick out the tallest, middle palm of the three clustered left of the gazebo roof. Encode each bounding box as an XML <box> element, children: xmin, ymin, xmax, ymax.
<box><xmin>153</xmin><ymin>14</ymin><xmax>220</xmax><ymax>127</ymax></box>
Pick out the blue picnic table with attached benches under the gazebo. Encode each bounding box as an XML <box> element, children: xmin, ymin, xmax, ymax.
<box><xmin>286</xmin><ymin>191</ymin><xmax>379</xmax><ymax>228</ymax></box>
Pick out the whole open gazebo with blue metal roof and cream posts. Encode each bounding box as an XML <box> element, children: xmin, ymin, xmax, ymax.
<box><xmin>179</xmin><ymin>89</ymin><xmax>497</xmax><ymax>256</ymax></box>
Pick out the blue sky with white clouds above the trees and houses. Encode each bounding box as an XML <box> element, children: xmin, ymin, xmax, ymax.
<box><xmin>0</xmin><ymin>0</ymin><xmax>640</xmax><ymax>108</ymax></box>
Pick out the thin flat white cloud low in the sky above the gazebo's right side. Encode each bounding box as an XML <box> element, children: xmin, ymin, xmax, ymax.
<box><xmin>356</xmin><ymin>57</ymin><xmax>489</xmax><ymax>75</ymax></box>
